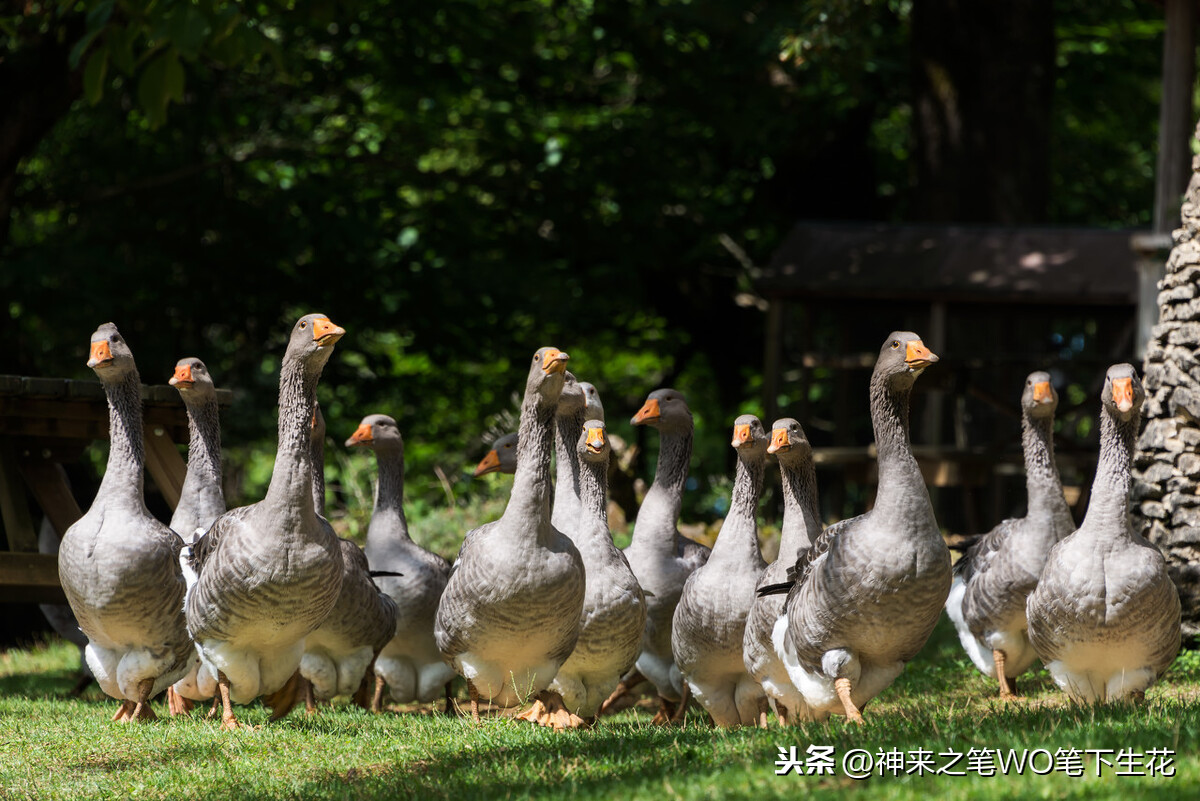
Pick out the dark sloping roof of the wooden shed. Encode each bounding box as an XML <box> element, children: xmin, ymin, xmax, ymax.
<box><xmin>756</xmin><ymin>222</ymin><xmax>1139</xmax><ymax>306</ymax></box>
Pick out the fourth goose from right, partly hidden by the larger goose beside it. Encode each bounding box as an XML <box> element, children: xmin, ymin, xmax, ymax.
<box><xmin>742</xmin><ymin>417</ymin><xmax>821</xmax><ymax>727</ymax></box>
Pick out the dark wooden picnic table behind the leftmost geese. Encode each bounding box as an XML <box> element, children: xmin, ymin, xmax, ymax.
<box><xmin>0</xmin><ymin>375</ymin><xmax>233</xmax><ymax>603</ymax></box>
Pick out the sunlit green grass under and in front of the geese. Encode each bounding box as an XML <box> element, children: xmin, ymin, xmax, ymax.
<box><xmin>0</xmin><ymin>620</ymin><xmax>1200</xmax><ymax>801</ymax></box>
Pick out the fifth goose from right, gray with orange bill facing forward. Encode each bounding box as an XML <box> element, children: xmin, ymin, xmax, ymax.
<box><xmin>671</xmin><ymin>415</ymin><xmax>770</xmax><ymax>728</ymax></box>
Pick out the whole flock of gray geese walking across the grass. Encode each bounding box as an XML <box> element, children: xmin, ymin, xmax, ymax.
<box><xmin>49</xmin><ymin>314</ymin><xmax>1180</xmax><ymax>729</ymax></box>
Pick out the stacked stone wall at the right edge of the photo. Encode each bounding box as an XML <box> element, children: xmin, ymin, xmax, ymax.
<box><xmin>1133</xmin><ymin>130</ymin><xmax>1200</xmax><ymax>643</ymax></box>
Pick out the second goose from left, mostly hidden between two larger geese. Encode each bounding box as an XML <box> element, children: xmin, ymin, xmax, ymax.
<box><xmin>167</xmin><ymin>356</ymin><xmax>226</xmax><ymax>715</ymax></box>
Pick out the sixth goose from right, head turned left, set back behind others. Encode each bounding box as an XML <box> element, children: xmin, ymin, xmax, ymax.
<box><xmin>601</xmin><ymin>389</ymin><xmax>709</xmax><ymax>723</ymax></box>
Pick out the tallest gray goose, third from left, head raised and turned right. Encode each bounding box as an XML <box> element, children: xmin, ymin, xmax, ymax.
<box><xmin>186</xmin><ymin>314</ymin><xmax>346</xmax><ymax>729</ymax></box>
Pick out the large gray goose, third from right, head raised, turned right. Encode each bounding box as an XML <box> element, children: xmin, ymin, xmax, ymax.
<box><xmin>760</xmin><ymin>331</ymin><xmax>950</xmax><ymax>723</ymax></box>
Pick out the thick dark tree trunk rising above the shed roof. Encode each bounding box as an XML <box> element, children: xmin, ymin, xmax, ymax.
<box><xmin>912</xmin><ymin>0</ymin><xmax>1055</xmax><ymax>224</ymax></box>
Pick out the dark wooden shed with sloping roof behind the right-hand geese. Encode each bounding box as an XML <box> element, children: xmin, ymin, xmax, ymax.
<box><xmin>756</xmin><ymin>222</ymin><xmax>1142</xmax><ymax>534</ymax></box>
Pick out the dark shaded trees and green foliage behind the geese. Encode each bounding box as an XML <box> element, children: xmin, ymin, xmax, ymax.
<box><xmin>0</xmin><ymin>0</ymin><xmax>1164</xmax><ymax>642</ymax></box>
